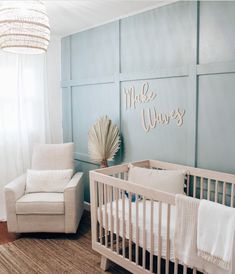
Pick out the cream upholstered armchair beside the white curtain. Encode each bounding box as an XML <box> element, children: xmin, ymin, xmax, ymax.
<box><xmin>5</xmin><ymin>143</ymin><xmax>84</xmax><ymax>233</ymax></box>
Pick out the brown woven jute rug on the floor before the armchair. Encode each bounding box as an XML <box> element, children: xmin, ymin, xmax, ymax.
<box><xmin>0</xmin><ymin>214</ymin><xmax>128</xmax><ymax>274</ymax></box>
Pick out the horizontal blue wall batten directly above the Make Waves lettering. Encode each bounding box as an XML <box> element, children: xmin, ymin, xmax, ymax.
<box><xmin>120</xmin><ymin>66</ymin><xmax>189</xmax><ymax>82</ymax></box>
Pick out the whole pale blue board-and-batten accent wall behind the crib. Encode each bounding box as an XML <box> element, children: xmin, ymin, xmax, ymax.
<box><xmin>61</xmin><ymin>1</ymin><xmax>235</xmax><ymax>201</ymax></box>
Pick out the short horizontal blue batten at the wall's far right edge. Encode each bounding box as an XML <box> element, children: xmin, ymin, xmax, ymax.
<box><xmin>197</xmin><ymin>61</ymin><xmax>235</xmax><ymax>75</ymax></box>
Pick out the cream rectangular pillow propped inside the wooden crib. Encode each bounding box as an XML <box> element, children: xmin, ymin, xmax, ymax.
<box><xmin>128</xmin><ymin>165</ymin><xmax>186</xmax><ymax>194</ymax></box>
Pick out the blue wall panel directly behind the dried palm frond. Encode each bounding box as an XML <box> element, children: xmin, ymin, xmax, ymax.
<box><xmin>72</xmin><ymin>84</ymin><xmax>119</xmax><ymax>159</ymax></box>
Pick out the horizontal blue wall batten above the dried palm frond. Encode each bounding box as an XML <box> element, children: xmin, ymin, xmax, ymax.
<box><xmin>61</xmin><ymin>76</ymin><xmax>115</xmax><ymax>88</ymax></box>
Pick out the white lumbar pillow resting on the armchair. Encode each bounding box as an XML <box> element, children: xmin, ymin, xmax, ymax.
<box><xmin>25</xmin><ymin>169</ymin><xmax>73</xmax><ymax>193</ymax></box>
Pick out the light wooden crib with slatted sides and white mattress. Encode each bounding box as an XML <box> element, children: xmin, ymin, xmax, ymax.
<box><xmin>90</xmin><ymin>160</ymin><xmax>235</xmax><ymax>274</ymax></box>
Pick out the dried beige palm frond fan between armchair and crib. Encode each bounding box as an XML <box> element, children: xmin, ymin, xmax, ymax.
<box><xmin>88</xmin><ymin>116</ymin><xmax>120</xmax><ymax>166</ymax></box>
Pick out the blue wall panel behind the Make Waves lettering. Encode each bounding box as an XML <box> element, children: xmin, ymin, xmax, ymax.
<box><xmin>121</xmin><ymin>77</ymin><xmax>191</xmax><ymax>163</ymax></box>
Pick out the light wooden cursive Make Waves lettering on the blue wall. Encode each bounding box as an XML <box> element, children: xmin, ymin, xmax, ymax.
<box><xmin>123</xmin><ymin>82</ymin><xmax>185</xmax><ymax>132</ymax></box>
